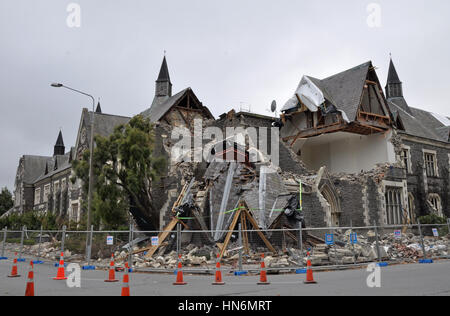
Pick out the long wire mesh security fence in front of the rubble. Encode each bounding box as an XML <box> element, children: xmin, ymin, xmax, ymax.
<box><xmin>0</xmin><ymin>221</ymin><xmax>450</xmax><ymax>274</ymax></box>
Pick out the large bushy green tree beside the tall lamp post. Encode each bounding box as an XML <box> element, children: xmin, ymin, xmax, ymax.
<box><xmin>72</xmin><ymin>115</ymin><xmax>166</xmax><ymax>229</ymax></box>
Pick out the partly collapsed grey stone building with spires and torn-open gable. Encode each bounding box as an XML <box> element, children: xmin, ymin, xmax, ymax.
<box><xmin>7</xmin><ymin>57</ymin><xmax>450</xmax><ymax>242</ymax></box>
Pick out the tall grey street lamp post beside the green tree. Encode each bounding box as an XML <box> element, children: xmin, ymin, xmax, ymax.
<box><xmin>51</xmin><ymin>83</ymin><xmax>95</xmax><ymax>265</ymax></box>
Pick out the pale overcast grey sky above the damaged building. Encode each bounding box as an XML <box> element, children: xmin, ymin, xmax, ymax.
<box><xmin>0</xmin><ymin>0</ymin><xmax>450</xmax><ymax>190</ymax></box>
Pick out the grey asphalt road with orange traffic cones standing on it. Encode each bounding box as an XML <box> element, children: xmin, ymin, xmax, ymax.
<box><xmin>0</xmin><ymin>252</ymin><xmax>450</xmax><ymax>296</ymax></box>
